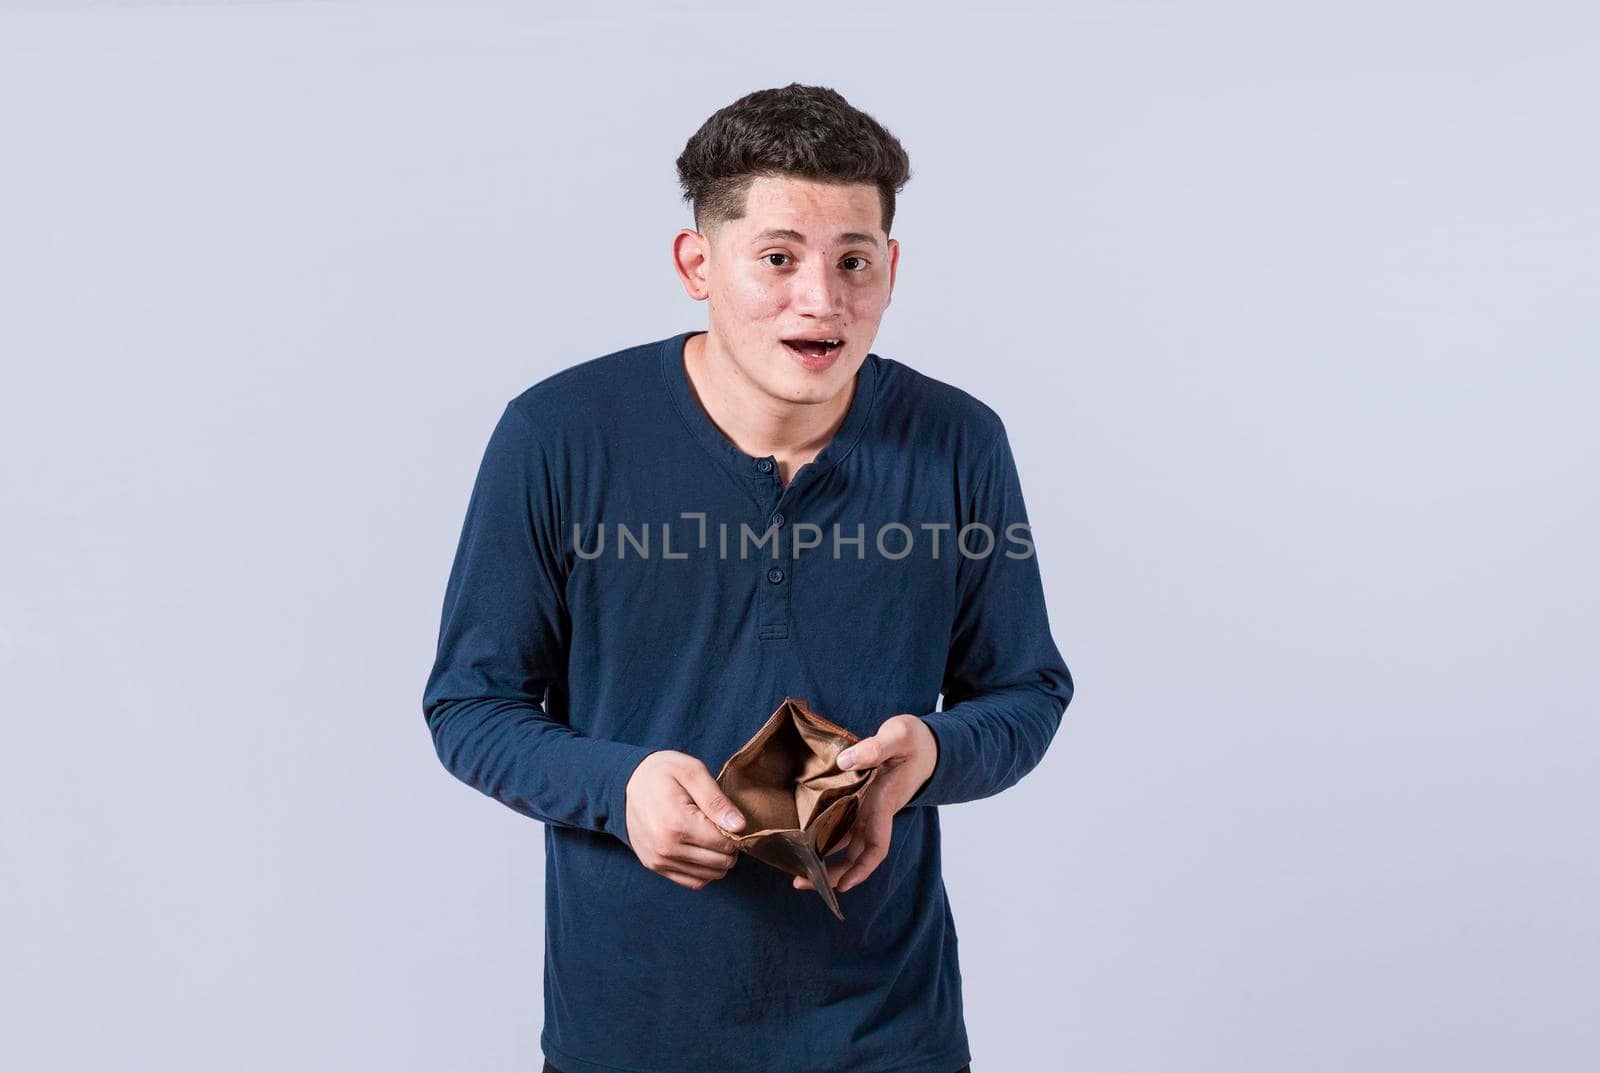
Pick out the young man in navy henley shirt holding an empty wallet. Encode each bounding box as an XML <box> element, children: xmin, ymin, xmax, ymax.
<box><xmin>422</xmin><ymin>85</ymin><xmax>1072</xmax><ymax>1073</ymax></box>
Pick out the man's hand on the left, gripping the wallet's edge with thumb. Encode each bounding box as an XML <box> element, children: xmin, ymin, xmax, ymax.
<box><xmin>626</xmin><ymin>748</ymin><xmax>744</xmax><ymax>891</ymax></box>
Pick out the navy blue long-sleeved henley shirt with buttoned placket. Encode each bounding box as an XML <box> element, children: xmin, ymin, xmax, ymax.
<box><xmin>422</xmin><ymin>331</ymin><xmax>1072</xmax><ymax>1073</ymax></box>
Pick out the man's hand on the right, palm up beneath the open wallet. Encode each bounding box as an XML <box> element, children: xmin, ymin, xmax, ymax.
<box><xmin>794</xmin><ymin>715</ymin><xmax>939</xmax><ymax>891</ymax></box>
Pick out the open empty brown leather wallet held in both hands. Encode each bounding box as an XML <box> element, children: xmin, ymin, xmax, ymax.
<box><xmin>717</xmin><ymin>697</ymin><xmax>878</xmax><ymax>919</ymax></box>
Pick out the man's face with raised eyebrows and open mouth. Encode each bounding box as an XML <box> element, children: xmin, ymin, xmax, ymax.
<box><xmin>678</xmin><ymin>178</ymin><xmax>899</xmax><ymax>403</ymax></box>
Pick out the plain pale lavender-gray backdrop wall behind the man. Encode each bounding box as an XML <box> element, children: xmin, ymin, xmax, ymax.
<box><xmin>0</xmin><ymin>2</ymin><xmax>1600</xmax><ymax>1073</ymax></box>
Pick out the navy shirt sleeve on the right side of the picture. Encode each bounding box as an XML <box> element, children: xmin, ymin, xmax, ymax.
<box><xmin>907</xmin><ymin>425</ymin><xmax>1072</xmax><ymax>808</ymax></box>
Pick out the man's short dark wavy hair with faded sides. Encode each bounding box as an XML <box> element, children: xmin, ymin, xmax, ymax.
<box><xmin>678</xmin><ymin>82</ymin><xmax>910</xmax><ymax>235</ymax></box>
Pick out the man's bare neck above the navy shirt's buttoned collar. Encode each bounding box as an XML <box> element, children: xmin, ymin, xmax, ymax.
<box><xmin>683</xmin><ymin>333</ymin><xmax>856</xmax><ymax>485</ymax></box>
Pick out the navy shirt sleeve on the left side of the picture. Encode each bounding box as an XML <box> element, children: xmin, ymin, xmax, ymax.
<box><xmin>422</xmin><ymin>401</ymin><xmax>654</xmax><ymax>848</ymax></box>
